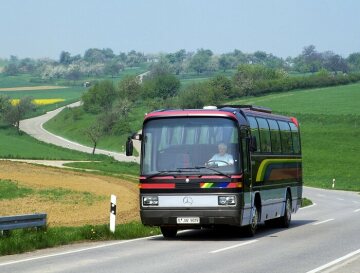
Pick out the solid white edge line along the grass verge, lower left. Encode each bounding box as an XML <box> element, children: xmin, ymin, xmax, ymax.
<box><xmin>0</xmin><ymin>235</ymin><xmax>161</xmax><ymax>267</ymax></box>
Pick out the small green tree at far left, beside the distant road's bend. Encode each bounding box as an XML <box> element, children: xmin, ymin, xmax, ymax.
<box><xmin>4</xmin><ymin>97</ymin><xmax>35</xmax><ymax>134</ymax></box>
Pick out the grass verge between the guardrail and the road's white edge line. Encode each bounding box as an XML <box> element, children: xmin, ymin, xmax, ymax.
<box><xmin>0</xmin><ymin>222</ymin><xmax>160</xmax><ymax>255</ymax></box>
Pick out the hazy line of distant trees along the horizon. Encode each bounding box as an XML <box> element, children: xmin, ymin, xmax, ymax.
<box><xmin>2</xmin><ymin>45</ymin><xmax>360</xmax><ymax>81</ymax></box>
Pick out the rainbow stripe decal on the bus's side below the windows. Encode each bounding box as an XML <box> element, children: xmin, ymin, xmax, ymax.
<box><xmin>256</xmin><ymin>158</ymin><xmax>302</xmax><ymax>182</ymax></box>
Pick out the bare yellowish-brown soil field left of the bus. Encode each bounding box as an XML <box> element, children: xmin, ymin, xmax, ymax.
<box><xmin>0</xmin><ymin>161</ymin><xmax>139</xmax><ymax>226</ymax></box>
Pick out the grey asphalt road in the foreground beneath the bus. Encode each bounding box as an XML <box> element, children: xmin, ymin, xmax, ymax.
<box><xmin>0</xmin><ymin>188</ymin><xmax>360</xmax><ymax>273</ymax></box>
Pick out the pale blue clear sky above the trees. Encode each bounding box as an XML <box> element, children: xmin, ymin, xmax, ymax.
<box><xmin>0</xmin><ymin>0</ymin><xmax>360</xmax><ymax>59</ymax></box>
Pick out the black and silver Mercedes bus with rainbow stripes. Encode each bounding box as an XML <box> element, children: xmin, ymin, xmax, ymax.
<box><xmin>126</xmin><ymin>105</ymin><xmax>303</xmax><ymax>237</ymax></box>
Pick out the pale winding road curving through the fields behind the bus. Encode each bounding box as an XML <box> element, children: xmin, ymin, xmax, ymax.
<box><xmin>20</xmin><ymin>102</ymin><xmax>139</xmax><ymax>162</ymax></box>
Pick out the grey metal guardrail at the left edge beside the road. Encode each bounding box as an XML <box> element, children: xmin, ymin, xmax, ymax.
<box><xmin>0</xmin><ymin>213</ymin><xmax>47</xmax><ymax>234</ymax></box>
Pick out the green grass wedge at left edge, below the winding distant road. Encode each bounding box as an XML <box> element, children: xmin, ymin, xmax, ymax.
<box><xmin>0</xmin><ymin>126</ymin><xmax>108</xmax><ymax>160</ymax></box>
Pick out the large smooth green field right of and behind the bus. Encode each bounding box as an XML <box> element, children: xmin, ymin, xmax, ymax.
<box><xmin>231</xmin><ymin>83</ymin><xmax>360</xmax><ymax>191</ymax></box>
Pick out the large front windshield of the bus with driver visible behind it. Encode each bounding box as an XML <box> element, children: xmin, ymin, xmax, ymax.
<box><xmin>141</xmin><ymin>117</ymin><xmax>240</xmax><ymax>175</ymax></box>
